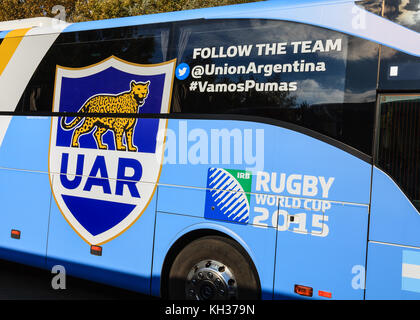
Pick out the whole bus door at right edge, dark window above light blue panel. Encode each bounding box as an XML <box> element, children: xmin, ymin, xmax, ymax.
<box><xmin>366</xmin><ymin>94</ymin><xmax>420</xmax><ymax>299</ymax></box>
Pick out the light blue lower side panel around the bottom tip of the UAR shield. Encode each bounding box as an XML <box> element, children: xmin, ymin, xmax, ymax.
<box><xmin>47</xmin><ymin>181</ymin><xmax>156</xmax><ymax>294</ymax></box>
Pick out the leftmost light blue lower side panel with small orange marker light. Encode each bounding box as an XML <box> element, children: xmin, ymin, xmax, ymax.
<box><xmin>0</xmin><ymin>169</ymin><xmax>51</xmax><ymax>267</ymax></box>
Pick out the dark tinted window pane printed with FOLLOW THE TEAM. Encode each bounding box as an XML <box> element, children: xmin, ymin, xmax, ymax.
<box><xmin>172</xmin><ymin>20</ymin><xmax>378</xmax><ymax>155</ymax></box>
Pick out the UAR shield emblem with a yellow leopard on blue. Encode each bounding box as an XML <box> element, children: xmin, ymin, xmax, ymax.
<box><xmin>49</xmin><ymin>56</ymin><xmax>175</xmax><ymax>245</ymax></box>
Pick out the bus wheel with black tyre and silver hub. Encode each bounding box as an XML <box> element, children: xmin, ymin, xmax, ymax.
<box><xmin>168</xmin><ymin>236</ymin><xmax>259</xmax><ymax>300</ymax></box>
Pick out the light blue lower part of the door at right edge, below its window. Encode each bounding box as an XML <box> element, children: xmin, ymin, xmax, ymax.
<box><xmin>366</xmin><ymin>167</ymin><xmax>420</xmax><ymax>299</ymax></box>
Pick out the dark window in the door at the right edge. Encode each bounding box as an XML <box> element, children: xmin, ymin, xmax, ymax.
<box><xmin>377</xmin><ymin>95</ymin><xmax>420</xmax><ymax>210</ymax></box>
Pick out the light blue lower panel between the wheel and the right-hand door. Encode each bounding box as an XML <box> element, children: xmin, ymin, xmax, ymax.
<box><xmin>275</xmin><ymin>203</ymin><xmax>369</xmax><ymax>300</ymax></box>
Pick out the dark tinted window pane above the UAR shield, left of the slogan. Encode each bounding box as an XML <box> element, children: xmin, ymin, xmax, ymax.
<box><xmin>17</xmin><ymin>27</ymin><xmax>169</xmax><ymax>112</ymax></box>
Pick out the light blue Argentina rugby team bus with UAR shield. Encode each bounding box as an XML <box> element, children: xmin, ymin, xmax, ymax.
<box><xmin>0</xmin><ymin>0</ymin><xmax>420</xmax><ymax>300</ymax></box>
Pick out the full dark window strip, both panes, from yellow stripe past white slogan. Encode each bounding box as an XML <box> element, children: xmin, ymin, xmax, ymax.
<box><xmin>17</xmin><ymin>19</ymin><xmax>378</xmax><ymax>155</ymax></box>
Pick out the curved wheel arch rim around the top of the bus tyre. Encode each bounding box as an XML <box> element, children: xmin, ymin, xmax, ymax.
<box><xmin>160</xmin><ymin>227</ymin><xmax>261</xmax><ymax>298</ymax></box>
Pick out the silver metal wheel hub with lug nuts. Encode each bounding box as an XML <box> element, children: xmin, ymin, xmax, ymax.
<box><xmin>185</xmin><ymin>260</ymin><xmax>238</xmax><ymax>300</ymax></box>
